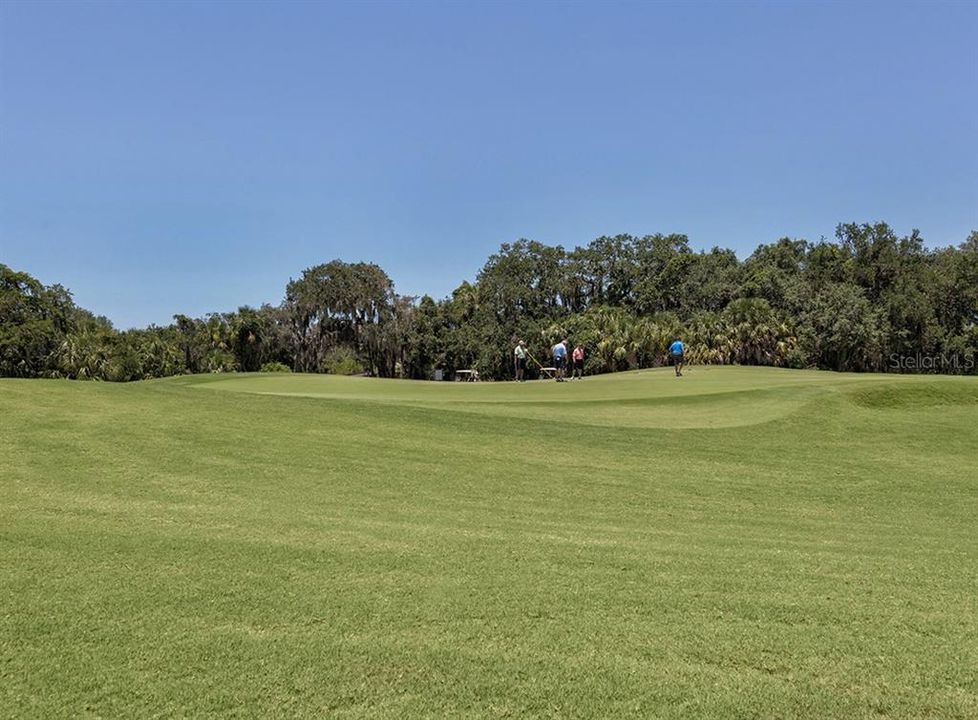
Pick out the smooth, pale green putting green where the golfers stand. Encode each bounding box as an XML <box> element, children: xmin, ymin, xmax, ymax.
<box><xmin>185</xmin><ymin>367</ymin><xmax>916</xmax><ymax>428</ymax></box>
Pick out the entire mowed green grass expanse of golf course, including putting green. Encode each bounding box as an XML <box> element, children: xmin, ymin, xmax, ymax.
<box><xmin>0</xmin><ymin>367</ymin><xmax>978</xmax><ymax>720</ymax></box>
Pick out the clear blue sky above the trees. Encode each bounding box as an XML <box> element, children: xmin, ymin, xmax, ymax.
<box><xmin>0</xmin><ymin>0</ymin><xmax>978</xmax><ymax>328</ymax></box>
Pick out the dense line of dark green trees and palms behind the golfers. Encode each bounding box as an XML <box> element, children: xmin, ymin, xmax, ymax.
<box><xmin>0</xmin><ymin>223</ymin><xmax>978</xmax><ymax>381</ymax></box>
